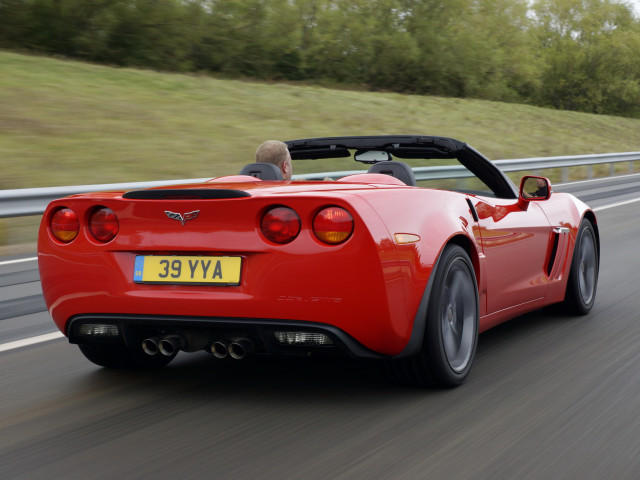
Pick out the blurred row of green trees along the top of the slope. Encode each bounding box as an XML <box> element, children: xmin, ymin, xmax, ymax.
<box><xmin>0</xmin><ymin>0</ymin><xmax>640</xmax><ymax>117</ymax></box>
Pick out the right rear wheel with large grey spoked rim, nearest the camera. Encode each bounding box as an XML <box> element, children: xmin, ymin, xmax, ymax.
<box><xmin>389</xmin><ymin>245</ymin><xmax>479</xmax><ymax>388</ymax></box>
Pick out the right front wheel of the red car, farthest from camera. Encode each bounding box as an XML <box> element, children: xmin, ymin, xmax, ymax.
<box><xmin>562</xmin><ymin>218</ymin><xmax>600</xmax><ymax>315</ymax></box>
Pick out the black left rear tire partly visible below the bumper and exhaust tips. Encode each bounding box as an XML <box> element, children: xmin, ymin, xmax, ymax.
<box><xmin>78</xmin><ymin>344</ymin><xmax>177</xmax><ymax>369</ymax></box>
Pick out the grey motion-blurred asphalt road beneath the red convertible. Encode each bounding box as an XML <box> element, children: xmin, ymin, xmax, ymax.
<box><xmin>0</xmin><ymin>176</ymin><xmax>640</xmax><ymax>480</ymax></box>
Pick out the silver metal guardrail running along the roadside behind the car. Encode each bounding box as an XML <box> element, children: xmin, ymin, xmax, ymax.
<box><xmin>0</xmin><ymin>152</ymin><xmax>640</xmax><ymax>218</ymax></box>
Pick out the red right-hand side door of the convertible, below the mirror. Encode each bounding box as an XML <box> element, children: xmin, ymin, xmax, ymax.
<box><xmin>470</xmin><ymin>197</ymin><xmax>551</xmax><ymax>314</ymax></box>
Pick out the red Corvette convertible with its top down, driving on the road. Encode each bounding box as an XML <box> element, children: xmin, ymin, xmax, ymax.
<box><xmin>38</xmin><ymin>135</ymin><xmax>600</xmax><ymax>387</ymax></box>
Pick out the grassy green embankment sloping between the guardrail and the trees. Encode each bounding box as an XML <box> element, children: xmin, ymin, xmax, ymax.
<box><xmin>0</xmin><ymin>52</ymin><xmax>640</xmax><ymax>246</ymax></box>
